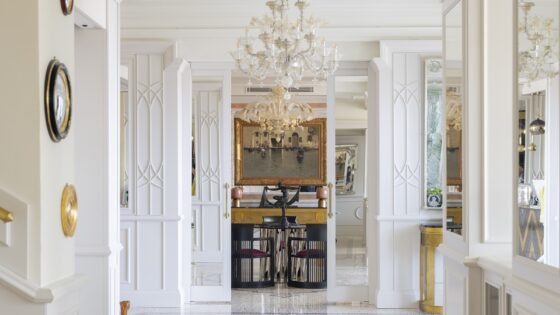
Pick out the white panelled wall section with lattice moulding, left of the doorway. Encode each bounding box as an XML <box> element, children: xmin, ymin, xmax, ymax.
<box><xmin>120</xmin><ymin>46</ymin><xmax>186</xmax><ymax>307</ymax></box>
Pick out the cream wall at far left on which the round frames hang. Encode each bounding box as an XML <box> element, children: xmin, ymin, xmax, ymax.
<box><xmin>0</xmin><ymin>1</ymin><xmax>82</xmax><ymax>314</ymax></box>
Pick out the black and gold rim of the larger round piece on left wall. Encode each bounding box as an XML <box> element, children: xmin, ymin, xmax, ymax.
<box><xmin>45</xmin><ymin>58</ymin><xmax>72</xmax><ymax>142</ymax></box>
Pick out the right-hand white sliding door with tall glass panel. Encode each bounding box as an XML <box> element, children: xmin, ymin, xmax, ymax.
<box><xmin>327</xmin><ymin>63</ymin><xmax>373</xmax><ymax>302</ymax></box>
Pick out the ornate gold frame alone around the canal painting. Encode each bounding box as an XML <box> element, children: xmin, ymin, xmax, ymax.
<box><xmin>233</xmin><ymin>118</ymin><xmax>327</xmax><ymax>186</ymax></box>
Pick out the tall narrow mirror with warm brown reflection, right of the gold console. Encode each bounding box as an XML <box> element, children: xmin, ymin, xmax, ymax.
<box><xmin>442</xmin><ymin>1</ymin><xmax>464</xmax><ymax>234</ymax></box>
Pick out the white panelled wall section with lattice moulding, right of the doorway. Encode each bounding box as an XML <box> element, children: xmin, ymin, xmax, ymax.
<box><xmin>368</xmin><ymin>41</ymin><xmax>441</xmax><ymax>308</ymax></box>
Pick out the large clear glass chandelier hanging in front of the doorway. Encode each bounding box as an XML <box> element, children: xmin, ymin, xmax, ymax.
<box><xmin>231</xmin><ymin>0</ymin><xmax>339</xmax><ymax>89</ymax></box>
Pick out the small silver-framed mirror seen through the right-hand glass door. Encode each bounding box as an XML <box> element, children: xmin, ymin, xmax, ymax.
<box><xmin>336</xmin><ymin>144</ymin><xmax>358</xmax><ymax>195</ymax></box>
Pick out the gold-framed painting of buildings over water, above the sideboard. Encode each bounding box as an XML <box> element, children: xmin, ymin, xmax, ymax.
<box><xmin>234</xmin><ymin>118</ymin><xmax>327</xmax><ymax>186</ymax></box>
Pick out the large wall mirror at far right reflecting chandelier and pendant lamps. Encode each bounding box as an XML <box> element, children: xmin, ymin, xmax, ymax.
<box><xmin>514</xmin><ymin>0</ymin><xmax>560</xmax><ymax>267</ymax></box>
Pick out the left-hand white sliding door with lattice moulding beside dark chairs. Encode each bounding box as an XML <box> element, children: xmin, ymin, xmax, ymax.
<box><xmin>186</xmin><ymin>70</ymin><xmax>231</xmax><ymax>301</ymax></box>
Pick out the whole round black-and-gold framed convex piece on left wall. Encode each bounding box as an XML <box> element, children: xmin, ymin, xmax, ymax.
<box><xmin>45</xmin><ymin>59</ymin><xmax>72</xmax><ymax>142</ymax></box>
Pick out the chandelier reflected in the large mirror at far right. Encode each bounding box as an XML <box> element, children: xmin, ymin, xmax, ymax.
<box><xmin>519</xmin><ymin>0</ymin><xmax>558</xmax><ymax>82</ymax></box>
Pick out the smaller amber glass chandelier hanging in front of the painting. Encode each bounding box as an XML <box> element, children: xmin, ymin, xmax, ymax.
<box><xmin>237</xmin><ymin>85</ymin><xmax>313</xmax><ymax>135</ymax></box>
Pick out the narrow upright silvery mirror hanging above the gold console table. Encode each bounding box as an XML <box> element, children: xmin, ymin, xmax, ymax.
<box><xmin>424</xmin><ymin>58</ymin><xmax>444</xmax><ymax>209</ymax></box>
